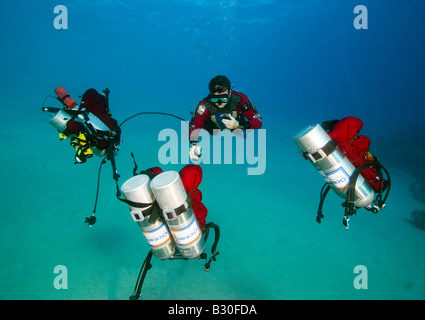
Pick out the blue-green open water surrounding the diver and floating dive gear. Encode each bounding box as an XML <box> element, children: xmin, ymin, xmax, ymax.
<box><xmin>0</xmin><ymin>0</ymin><xmax>425</xmax><ymax>299</ymax></box>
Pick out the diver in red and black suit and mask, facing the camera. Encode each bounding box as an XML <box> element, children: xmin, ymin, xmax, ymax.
<box><xmin>189</xmin><ymin>75</ymin><xmax>262</xmax><ymax>161</ymax></box>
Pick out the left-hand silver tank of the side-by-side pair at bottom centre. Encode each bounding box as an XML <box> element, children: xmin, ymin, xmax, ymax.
<box><xmin>121</xmin><ymin>174</ymin><xmax>176</xmax><ymax>259</ymax></box>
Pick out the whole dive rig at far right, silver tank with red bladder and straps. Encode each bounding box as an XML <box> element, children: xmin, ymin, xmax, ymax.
<box><xmin>294</xmin><ymin>117</ymin><xmax>391</xmax><ymax>229</ymax></box>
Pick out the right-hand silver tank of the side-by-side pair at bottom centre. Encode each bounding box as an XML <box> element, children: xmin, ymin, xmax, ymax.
<box><xmin>150</xmin><ymin>171</ymin><xmax>205</xmax><ymax>258</ymax></box>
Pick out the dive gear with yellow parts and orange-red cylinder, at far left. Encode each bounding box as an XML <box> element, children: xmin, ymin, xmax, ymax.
<box><xmin>42</xmin><ymin>87</ymin><xmax>121</xmax><ymax>164</ymax></box>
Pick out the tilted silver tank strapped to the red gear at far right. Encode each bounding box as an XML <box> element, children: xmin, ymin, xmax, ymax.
<box><xmin>294</xmin><ymin>124</ymin><xmax>375</xmax><ymax>207</ymax></box>
